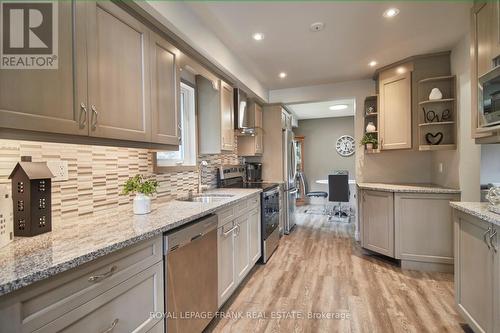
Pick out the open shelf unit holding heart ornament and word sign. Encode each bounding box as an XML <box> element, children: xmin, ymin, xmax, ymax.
<box><xmin>418</xmin><ymin>75</ymin><xmax>457</xmax><ymax>151</ymax></box>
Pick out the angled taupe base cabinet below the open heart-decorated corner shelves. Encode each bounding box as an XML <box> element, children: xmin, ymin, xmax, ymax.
<box><xmin>358</xmin><ymin>189</ymin><xmax>460</xmax><ymax>271</ymax></box>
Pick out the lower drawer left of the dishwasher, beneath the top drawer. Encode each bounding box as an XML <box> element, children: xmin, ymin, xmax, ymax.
<box><xmin>35</xmin><ymin>262</ymin><xmax>163</xmax><ymax>333</ymax></box>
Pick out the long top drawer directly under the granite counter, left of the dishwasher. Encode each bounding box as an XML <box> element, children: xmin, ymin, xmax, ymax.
<box><xmin>0</xmin><ymin>237</ymin><xmax>162</xmax><ymax>332</ymax></box>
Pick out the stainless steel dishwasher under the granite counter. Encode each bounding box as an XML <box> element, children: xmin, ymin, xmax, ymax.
<box><xmin>164</xmin><ymin>215</ymin><xmax>218</xmax><ymax>333</ymax></box>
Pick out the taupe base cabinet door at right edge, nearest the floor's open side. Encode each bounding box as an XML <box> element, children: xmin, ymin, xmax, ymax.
<box><xmin>455</xmin><ymin>214</ymin><xmax>498</xmax><ymax>332</ymax></box>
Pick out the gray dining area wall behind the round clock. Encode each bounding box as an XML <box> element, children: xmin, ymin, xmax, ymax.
<box><xmin>294</xmin><ymin>117</ymin><xmax>357</xmax><ymax>191</ymax></box>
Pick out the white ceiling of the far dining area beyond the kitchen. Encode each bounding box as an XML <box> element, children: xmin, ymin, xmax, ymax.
<box><xmin>287</xmin><ymin>99</ymin><xmax>354</xmax><ymax>120</ymax></box>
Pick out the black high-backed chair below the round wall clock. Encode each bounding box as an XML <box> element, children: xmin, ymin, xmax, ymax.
<box><xmin>328</xmin><ymin>171</ymin><xmax>351</xmax><ymax>219</ymax></box>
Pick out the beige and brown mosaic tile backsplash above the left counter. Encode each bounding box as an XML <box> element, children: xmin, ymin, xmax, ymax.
<box><xmin>0</xmin><ymin>140</ymin><xmax>242</xmax><ymax>217</ymax></box>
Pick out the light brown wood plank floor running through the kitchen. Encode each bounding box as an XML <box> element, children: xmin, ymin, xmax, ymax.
<box><xmin>207</xmin><ymin>206</ymin><xmax>464</xmax><ymax>333</ymax></box>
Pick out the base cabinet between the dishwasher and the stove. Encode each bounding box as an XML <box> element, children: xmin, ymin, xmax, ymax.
<box><xmin>217</xmin><ymin>196</ymin><xmax>261</xmax><ymax>308</ymax></box>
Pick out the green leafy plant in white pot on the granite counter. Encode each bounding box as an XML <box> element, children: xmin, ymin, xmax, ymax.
<box><xmin>122</xmin><ymin>175</ymin><xmax>158</xmax><ymax>215</ymax></box>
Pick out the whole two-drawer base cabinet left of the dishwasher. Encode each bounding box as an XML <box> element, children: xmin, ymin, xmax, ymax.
<box><xmin>0</xmin><ymin>237</ymin><xmax>164</xmax><ymax>333</ymax></box>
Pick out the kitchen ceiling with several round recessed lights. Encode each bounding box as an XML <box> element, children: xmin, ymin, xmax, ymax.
<box><xmin>189</xmin><ymin>1</ymin><xmax>471</xmax><ymax>89</ymax></box>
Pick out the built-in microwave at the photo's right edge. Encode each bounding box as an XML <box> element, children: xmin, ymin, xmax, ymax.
<box><xmin>477</xmin><ymin>66</ymin><xmax>500</xmax><ymax>128</ymax></box>
